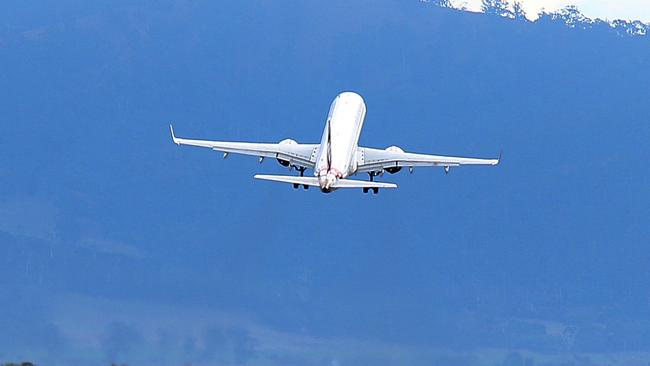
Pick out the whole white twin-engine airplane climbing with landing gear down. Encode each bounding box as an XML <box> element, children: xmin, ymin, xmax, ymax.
<box><xmin>169</xmin><ymin>92</ymin><xmax>501</xmax><ymax>194</ymax></box>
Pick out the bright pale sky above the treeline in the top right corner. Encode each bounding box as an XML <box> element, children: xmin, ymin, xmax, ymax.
<box><xmin>452</xmin><ymin>0</ymin><xmax>650</xmax><ymax>23</ymax></box>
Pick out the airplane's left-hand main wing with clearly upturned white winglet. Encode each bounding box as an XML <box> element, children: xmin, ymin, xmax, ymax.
<box><xmin>169</xmin><ymin>125</ymin><xmax>320</xmax><ymax>169</ymax></box>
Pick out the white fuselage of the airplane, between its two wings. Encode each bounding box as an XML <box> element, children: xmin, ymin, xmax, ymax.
<box><xmin>314</xmin><ymin>92</ymin><xmax>366</xmax><ymax>192</ymax></box>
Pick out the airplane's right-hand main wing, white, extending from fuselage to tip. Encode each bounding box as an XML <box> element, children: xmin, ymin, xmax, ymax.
<box><xmin>358</xmin><ymin>147</ymin><xmax>501</xmax><ymax>172</ymax></box>
